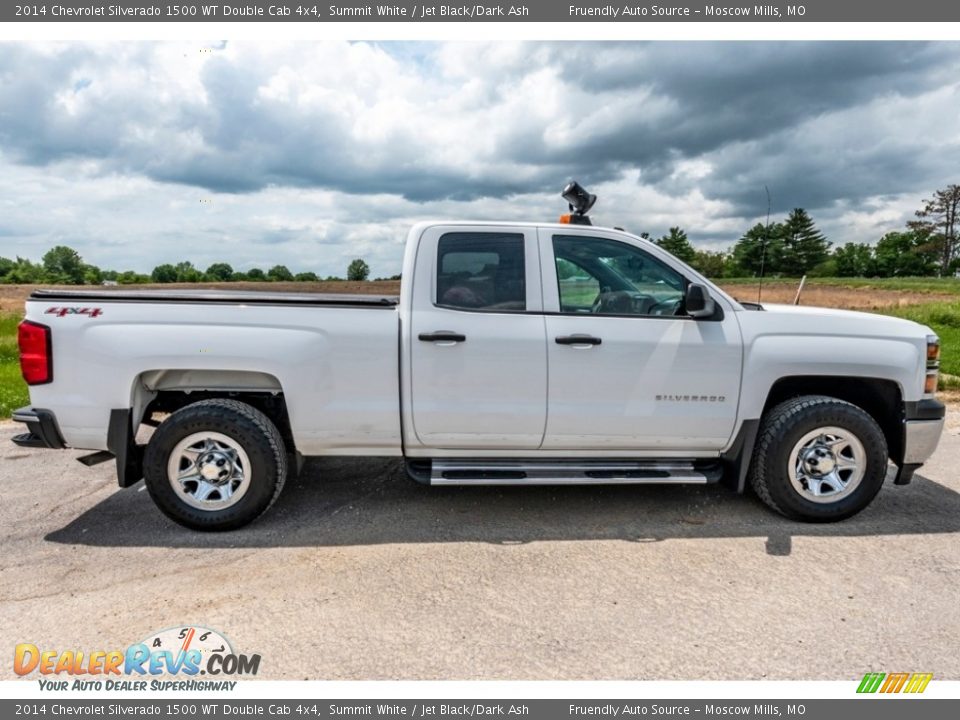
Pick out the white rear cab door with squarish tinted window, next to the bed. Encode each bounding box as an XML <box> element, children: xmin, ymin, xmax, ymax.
<box><xmin>410</xmin><ymin>226</ymin><xmax>547</xmax><ymax>450</ymax></box>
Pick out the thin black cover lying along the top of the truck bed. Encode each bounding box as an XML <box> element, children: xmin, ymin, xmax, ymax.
<box><xmin>30</xmin><ymin>289</ymin><xmax>400</xmax><ymax>308</ymax></box>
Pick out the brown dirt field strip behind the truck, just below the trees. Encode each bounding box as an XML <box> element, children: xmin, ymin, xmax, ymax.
<box><xmin>0</xmin><ymin>280</ymin><xmax>957</xmax><ymax>312</ymax></box>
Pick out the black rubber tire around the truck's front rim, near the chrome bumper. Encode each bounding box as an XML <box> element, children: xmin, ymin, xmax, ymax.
<box><xmin>749</xmin><ymin>395</ymin><xmax>887</xmax><ymax>522</ymax></box>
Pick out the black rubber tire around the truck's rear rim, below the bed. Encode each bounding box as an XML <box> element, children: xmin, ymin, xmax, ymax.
<box><xmin>143</xmin><ymin>399</ymin><xmax>287</xmax><ymax>531</ymax></box>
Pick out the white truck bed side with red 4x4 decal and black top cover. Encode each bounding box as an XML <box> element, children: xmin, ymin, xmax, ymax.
<box><xmin>27</xmin><ymin>288</ymin><xmax>400</xmax><ymax>455</ymax></box>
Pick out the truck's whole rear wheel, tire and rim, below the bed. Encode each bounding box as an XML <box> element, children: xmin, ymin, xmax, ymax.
<box><xmin>143</xmin><ymin>399</ymin><xmax>287</xmax><ymax>531</ymax></box>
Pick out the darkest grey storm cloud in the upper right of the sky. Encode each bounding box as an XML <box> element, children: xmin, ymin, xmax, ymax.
<box><xmin>555</xmin><ymin>42</ymin><xmax>958</xmax><ymax>162</ymax></box>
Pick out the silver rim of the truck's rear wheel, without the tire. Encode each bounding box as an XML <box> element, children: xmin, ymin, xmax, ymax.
<box><xmin>167</xmin><ymin>432</ymin><xmax>250</xmax><ymax>512</ymax></box>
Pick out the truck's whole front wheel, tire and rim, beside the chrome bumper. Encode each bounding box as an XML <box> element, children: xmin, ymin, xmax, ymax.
<box><xmin>750</xmin><ymin>395</ymin><xmax>887</xmax><ymax>522</ymax></box>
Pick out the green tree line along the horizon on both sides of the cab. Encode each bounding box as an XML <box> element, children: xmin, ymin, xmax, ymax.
<box><xmin>0</xmin><ymin>185</ymin><xmax>960</xmax><ymax>285</ymax></box>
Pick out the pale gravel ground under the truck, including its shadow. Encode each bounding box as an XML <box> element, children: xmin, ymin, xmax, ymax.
<box><xmin>0</xmin><ymin>416</ymin><xmax>960</xmax><ymax>680</ymax></box>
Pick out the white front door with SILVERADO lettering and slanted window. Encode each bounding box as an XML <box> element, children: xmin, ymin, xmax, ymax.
<box><xmin>540</xmin><ymin>227</ymin><xmax>742</xmax><ymax>452</ymax></box>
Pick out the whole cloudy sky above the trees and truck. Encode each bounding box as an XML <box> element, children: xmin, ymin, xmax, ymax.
<box><xmin>0</xmin><ymin>42</ymin><xmax>960</xmax><ymax>276</ymax></box>
